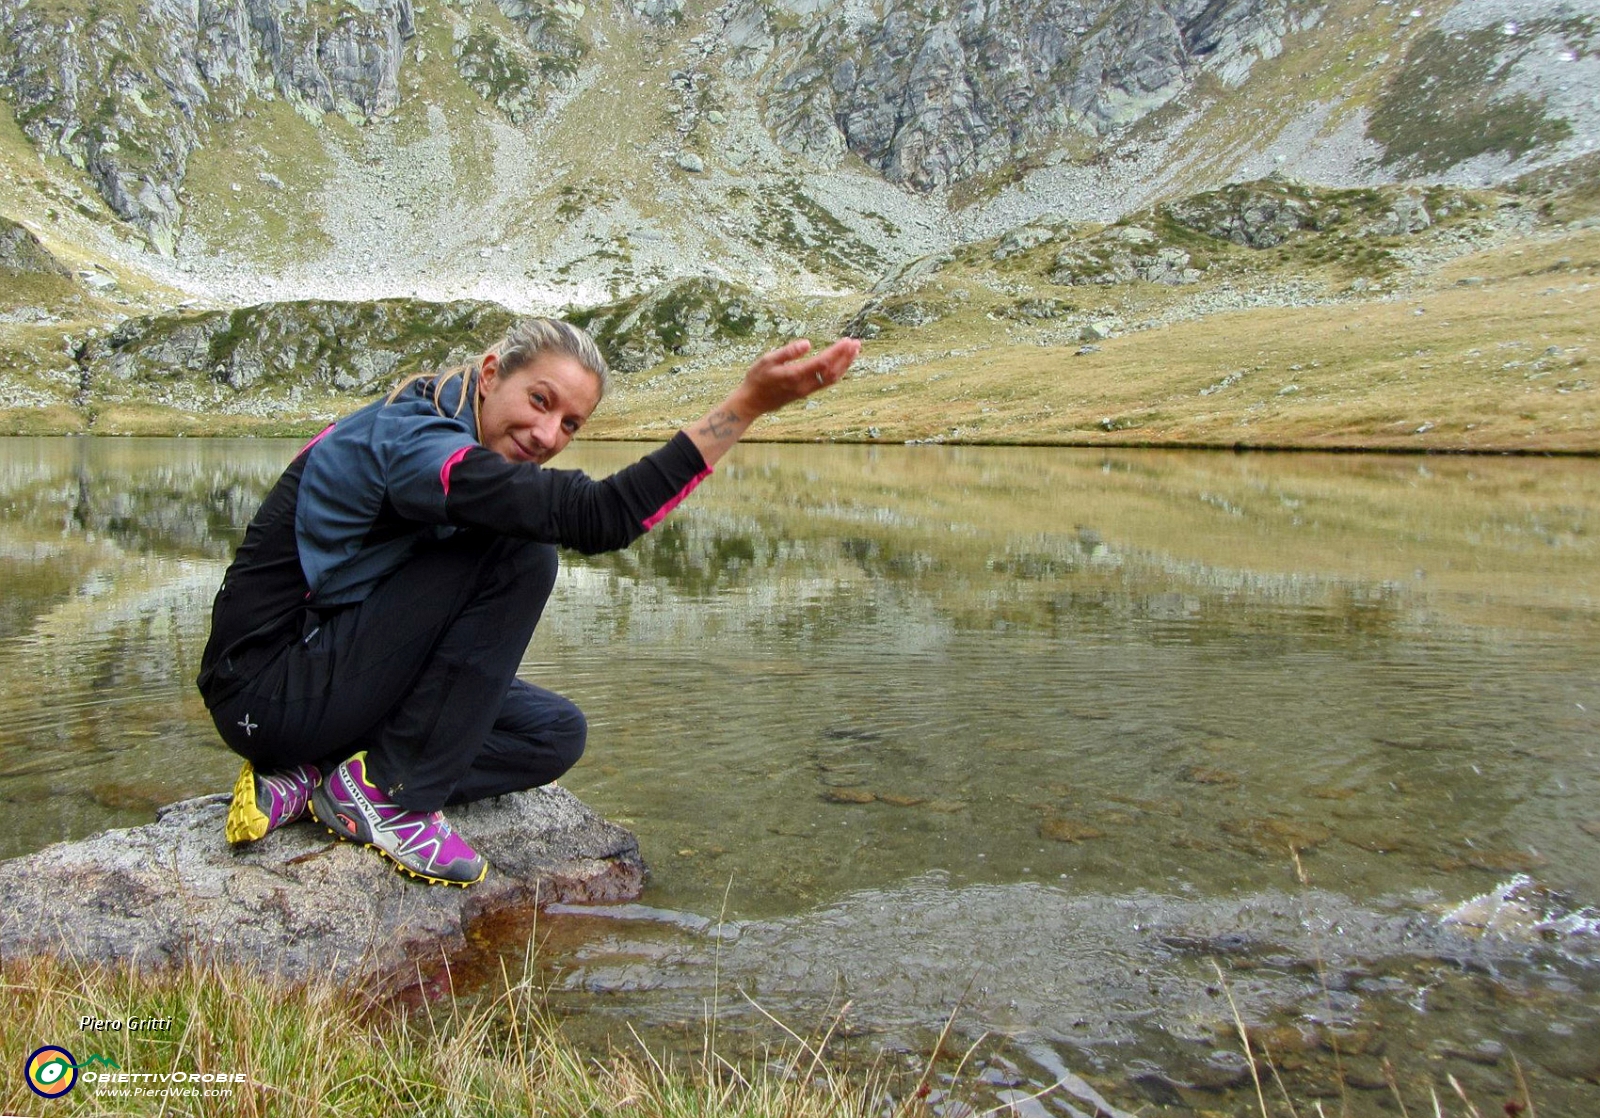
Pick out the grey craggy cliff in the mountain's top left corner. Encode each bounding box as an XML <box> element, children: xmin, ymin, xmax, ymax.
<box><xmin>0</xmin><ymin>0</ymin><xmax>414</xmax><ymax>254</ymax></box>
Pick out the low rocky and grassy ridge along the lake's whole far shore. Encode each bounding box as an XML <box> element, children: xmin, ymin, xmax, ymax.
<box><xmin>18</xmin><ymin>171</ymin><xmax>1600</xmax><ymax>449</ymax></box>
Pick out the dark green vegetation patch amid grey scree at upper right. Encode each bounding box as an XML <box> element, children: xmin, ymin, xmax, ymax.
<box><xmin>1366</xmin><ymin>21</ymin><xmax>1573</xmax><ymax>174</ymax></box>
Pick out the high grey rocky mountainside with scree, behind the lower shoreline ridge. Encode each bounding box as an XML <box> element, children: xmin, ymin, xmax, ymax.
<box><xmin>0</xmin><ymin>0</ymin><xmax>1600</xmax><ymax>307</ymax></box>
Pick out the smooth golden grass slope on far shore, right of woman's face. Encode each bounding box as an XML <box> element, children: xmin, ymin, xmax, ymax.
<box><xmin>590</xmin><ymin>230</ymin><xmax>1600</xmax><ymax>453</ymax></box>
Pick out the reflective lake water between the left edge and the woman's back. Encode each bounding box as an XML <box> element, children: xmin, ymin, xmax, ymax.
<box><xmin>0</xmin><ymin>438</ymin><xmax>293</xmax><ymax>854</ymax></box>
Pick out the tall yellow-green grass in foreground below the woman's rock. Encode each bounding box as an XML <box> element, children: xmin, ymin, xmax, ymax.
<box><xmin>0</xmin><ymin>958</ymin><xmax>902</xmax><ymax>1118</ymax></box>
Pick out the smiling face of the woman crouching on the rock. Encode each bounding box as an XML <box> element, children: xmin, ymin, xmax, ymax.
<box><xmin>478</xmin><ymin>353</ymin><xmax>600</xmax><ymax>465</ymax></box>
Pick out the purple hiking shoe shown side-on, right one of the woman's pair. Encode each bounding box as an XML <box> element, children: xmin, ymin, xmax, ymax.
<box><xmin>310</xmin><ymin>753</ymin><xmax>490</xmax><ymax>888</ymax></box>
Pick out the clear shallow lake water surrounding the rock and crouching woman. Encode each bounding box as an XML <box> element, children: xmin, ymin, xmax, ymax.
<box><xmin>0</xmin><ymin>440</ymin><xmax>1600</xmax><ymax>1113</ymax></box>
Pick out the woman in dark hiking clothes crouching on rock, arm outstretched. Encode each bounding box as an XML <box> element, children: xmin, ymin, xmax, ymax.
<box><xmin>198</xmin><ymin>318</ymin><xmax>861</xmax><ymax>886</ymax></box>
